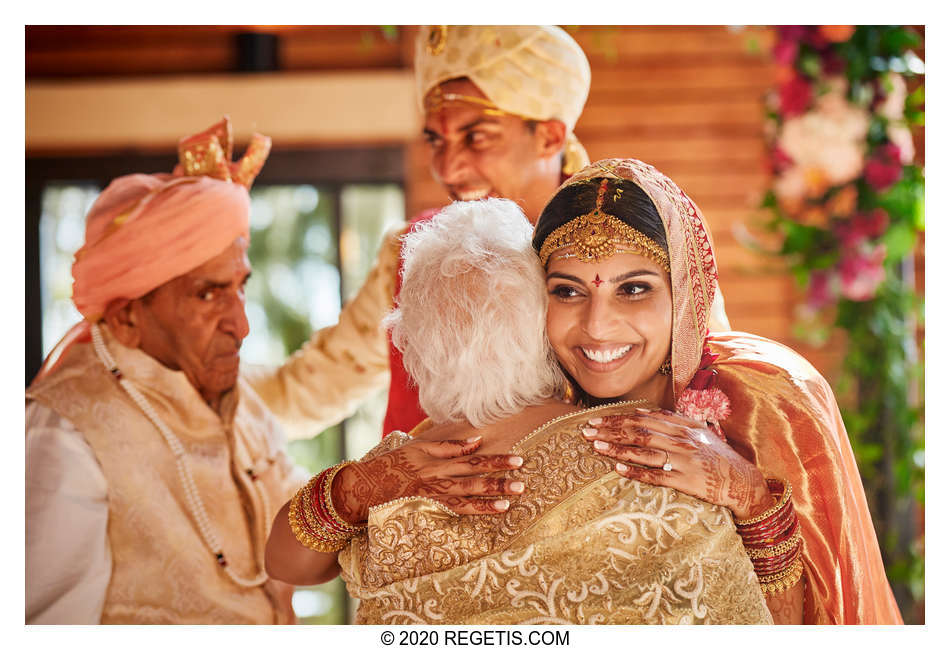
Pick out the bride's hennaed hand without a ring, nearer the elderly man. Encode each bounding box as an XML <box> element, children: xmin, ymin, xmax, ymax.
<box><xmin>333</xmin><ymin>437</ymin><xmax>524</xmax><ymax>524</ymax></box>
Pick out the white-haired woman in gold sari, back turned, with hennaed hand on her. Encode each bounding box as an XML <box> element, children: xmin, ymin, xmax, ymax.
<box><xmin>267</xmin><ymin>199</ymin><xmax>772</xmax><ymax>624</ymax></box>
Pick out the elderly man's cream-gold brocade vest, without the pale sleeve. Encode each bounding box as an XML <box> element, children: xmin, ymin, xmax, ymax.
<box><xmin>26</xmin><ymin>328</ymin><xmax>295</xmax><ymax>624</ymax></box>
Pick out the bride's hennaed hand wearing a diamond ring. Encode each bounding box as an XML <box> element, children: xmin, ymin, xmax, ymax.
<box><xmin>583</xmin><ymin>409</ymin><xmax>775</xmax><ymax>519</ymax></box>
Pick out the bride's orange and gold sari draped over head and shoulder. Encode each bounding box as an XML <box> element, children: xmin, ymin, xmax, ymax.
<box><xmin>562</xmin><ymin>159</ymin><xmax>902</xmax><ymax>625</ymax></box>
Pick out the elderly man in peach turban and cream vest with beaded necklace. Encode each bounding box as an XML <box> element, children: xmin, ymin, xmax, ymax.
<box><xmin>26</xmin><ymin>119</ymin><xmax>299</xmax><ymax>623</ymax></box>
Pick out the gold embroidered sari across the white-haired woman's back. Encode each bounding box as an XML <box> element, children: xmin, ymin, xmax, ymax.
<box><xmin>339</xmin><ymin>404</ymin><xmax>772</xmax><ymax>625</ymax></box>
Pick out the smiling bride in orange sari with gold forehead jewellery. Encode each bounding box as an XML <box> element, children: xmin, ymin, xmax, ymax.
<box><xmin>533</xmin><ymin>159</ymin><xmax>901</xmax><ymax>624</ymax></box>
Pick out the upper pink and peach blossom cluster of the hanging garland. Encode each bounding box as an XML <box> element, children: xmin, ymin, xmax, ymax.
<box><xmin>766</xmin><ymin>25</ymin><xmax>923</xmax><ymax>316</ymax></box>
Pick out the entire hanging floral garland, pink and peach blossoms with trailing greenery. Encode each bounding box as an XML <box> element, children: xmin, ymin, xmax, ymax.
<box><xmin>763</xmin><ymin>25</ymin><xmax>924</xmax><ymax>622</ymax></box>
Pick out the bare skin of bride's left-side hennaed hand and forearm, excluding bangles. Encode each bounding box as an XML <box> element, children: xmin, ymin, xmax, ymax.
<box><xmin>265</xmin><ymin>436</ymin><xmax>524</xmax><ymax>585</ymax></box>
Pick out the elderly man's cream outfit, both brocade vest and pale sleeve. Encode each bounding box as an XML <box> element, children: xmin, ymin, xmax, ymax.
<box><xmin>26</xmin><ymin>330</ymin><xmax>305</xmax><ymax>623</ymax></box>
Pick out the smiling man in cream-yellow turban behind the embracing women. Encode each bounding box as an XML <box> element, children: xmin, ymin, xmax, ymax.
<box><xmin>248</xmin><ymin>25</ymin><xmax>729</xmax><ymax>438</ymax></box>
